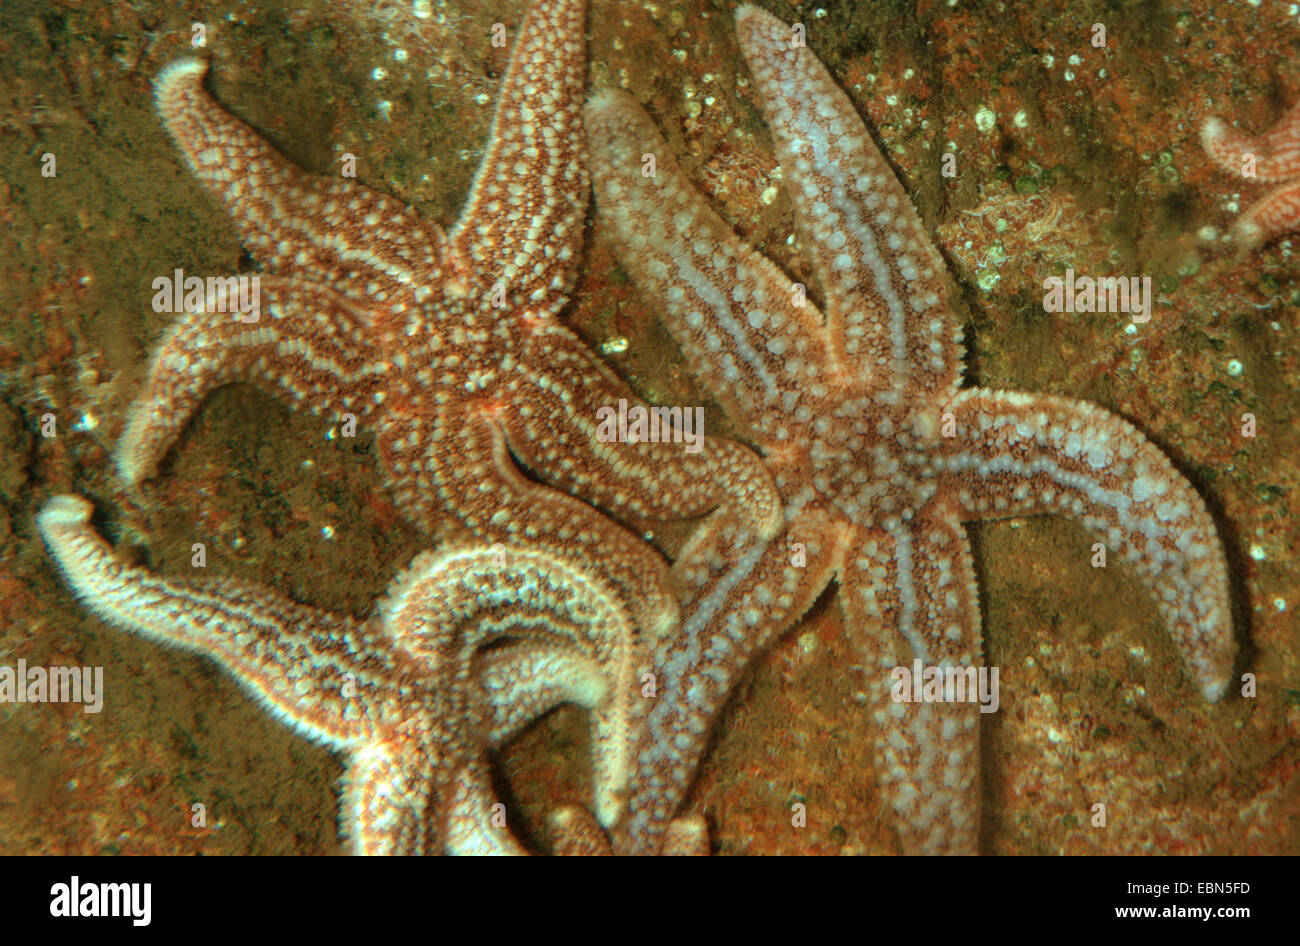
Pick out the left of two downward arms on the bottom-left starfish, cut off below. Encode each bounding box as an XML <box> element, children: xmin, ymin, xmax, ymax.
<box><xmin>342</xmin><ymin>742</ymin><xmax>433</xmax><ymax>856</ymax></box>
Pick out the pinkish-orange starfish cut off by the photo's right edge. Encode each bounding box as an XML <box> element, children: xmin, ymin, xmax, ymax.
<box><xmin>1201</xmin><ymin>99</ymin><xmax>1300</xmax><ymax>249</ymax></box>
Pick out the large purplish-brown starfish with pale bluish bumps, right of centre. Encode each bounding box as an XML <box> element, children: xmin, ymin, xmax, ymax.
<box><xmin>585</xmin><ymin>6</ymin><xmax>1234</xmax><ymax>852</ymax></box>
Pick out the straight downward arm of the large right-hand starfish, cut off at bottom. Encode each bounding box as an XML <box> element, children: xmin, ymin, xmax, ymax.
<box><xmin>840</xmin><ymin>507</ymin><xmax>982</xmax><ymax>854</ymax></box>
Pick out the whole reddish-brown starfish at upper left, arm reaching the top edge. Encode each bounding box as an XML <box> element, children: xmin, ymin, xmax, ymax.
<box><xmin>117</xmin><ymin>0</ymin><xmax>780</xmax><ymax>662</ymax></box>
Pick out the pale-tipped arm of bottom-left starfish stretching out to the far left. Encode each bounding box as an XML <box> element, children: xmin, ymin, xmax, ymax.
<box><xmin>36</xmin><ymin>495</ymin><xmax>393</xmax><ymax>748</ymax></box>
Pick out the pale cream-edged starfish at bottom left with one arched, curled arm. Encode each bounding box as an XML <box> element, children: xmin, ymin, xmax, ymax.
<box><xmin>38</xmin><ymin>495</ymin><xmax>640</xmax><ymax>854</ymax></box>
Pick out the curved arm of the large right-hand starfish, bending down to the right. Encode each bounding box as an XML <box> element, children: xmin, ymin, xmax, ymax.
<box><xmin>927</xmin><ymin>389</ymin><xmax>1236</xmax><ymax>700</ymax></box>
